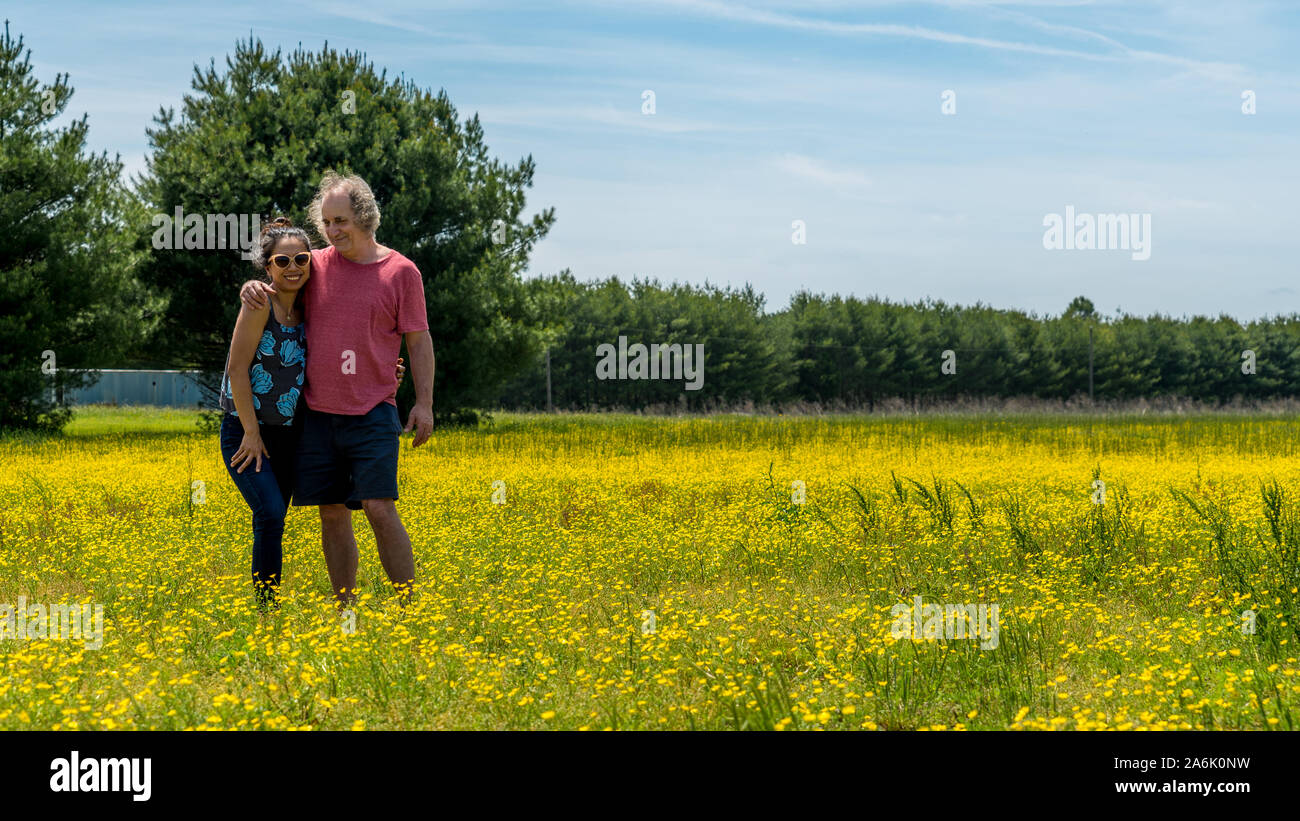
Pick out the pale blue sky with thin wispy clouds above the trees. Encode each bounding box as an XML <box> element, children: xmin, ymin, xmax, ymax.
<box><xmin>10</xmin><ymin>0</ymin><xmax>1300</xmax><ymax>321</ymax></box>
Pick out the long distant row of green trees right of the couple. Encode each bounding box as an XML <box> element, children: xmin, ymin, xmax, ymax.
<box><xmin>498</xmin><ymin>280</ymin><xmax>1300</xmax><ymax>411</ymax></box>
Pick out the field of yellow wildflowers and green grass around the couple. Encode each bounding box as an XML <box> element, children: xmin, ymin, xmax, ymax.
<box><xmin>0</xmin><ymin>409</ymin><xmax>1300</xmax><ymax>730</ymax></box>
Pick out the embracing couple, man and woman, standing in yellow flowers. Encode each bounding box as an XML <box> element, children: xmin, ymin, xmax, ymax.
<box><xmin>220</xmin><ymin>171</ymin><xmax>434</xmax><ymax>607</ymax></box>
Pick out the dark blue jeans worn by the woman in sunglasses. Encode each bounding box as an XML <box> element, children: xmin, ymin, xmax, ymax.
<box><xmin>221</xmin><ymin>413</ymin><xmax>302</xmax><ymax>604</ymax></box>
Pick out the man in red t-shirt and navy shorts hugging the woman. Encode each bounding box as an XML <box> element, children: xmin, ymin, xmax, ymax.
<box><xmin>241</xmin><ymin>171</ymin><xmax>434</xmax><ymax>607</ymax></box>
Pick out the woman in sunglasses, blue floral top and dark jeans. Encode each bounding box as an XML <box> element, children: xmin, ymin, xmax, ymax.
<box><xmin>220</xmin><ymin>217</ymin><xmax>406</xmax><ymax>609</ymax></box>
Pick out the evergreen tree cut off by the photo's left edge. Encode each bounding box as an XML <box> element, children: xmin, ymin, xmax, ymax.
<box><xmin>0</xmin><ymin>21</ymin><xmax>161</xmax><ymax>429</ymax></box>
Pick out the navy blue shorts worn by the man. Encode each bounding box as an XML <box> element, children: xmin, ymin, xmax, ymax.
<box><xmin>294</xmin><ymin>401</ymin><xmax>402</xmax><ymax>511</ymax></box>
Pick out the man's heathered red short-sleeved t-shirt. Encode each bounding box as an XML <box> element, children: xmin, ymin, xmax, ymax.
<box><xmin>302</xmin><ymin>240</ymin><xmax>429</xmax><ymax>416</ymax></box>
